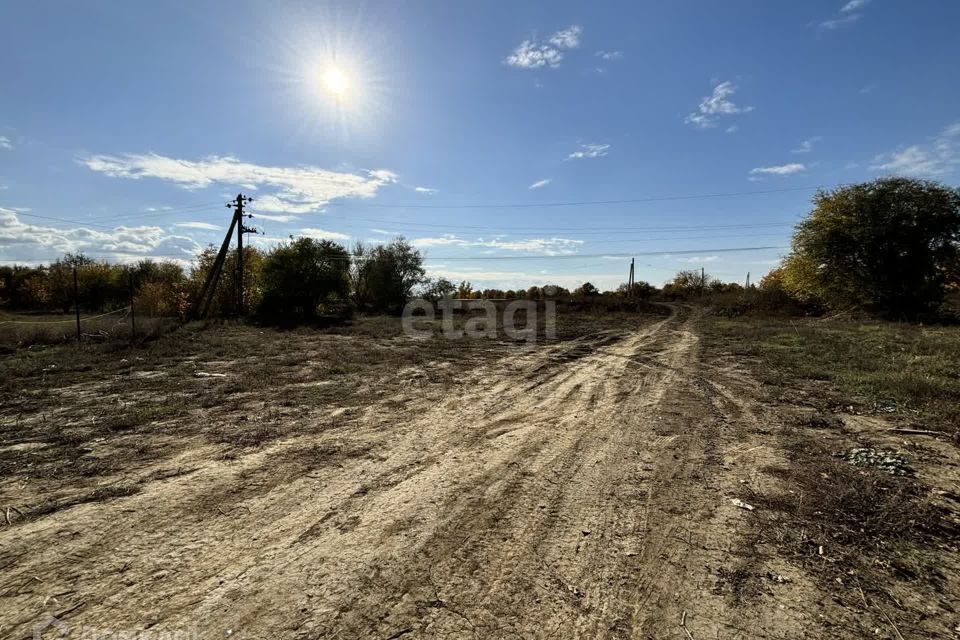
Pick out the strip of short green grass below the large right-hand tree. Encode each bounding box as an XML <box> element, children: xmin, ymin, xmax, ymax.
<box><xmin>705</xmin><ymin>318</ymin><xmax>960</xmax><ymax>438</ymax></box>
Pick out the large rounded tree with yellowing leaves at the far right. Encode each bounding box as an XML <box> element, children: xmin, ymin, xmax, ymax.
<box><xmin>783</xmin><ymin>178</ymin><xmax>960</xmax><ymax>315</ymax></box>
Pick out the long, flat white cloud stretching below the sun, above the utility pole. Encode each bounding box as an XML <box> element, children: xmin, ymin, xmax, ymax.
<box><xmin>80</xmin><ymin>153</ymin><xmax>397</xmax><ymax>213</ymax></box>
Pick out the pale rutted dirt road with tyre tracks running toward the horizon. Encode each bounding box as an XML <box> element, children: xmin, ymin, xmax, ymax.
<box><xmin>0</xmin><ymin>310</ymin><xmax>818</xmax><ymax>640</ymax></box>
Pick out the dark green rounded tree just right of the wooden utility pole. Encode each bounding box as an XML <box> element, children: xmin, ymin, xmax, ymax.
<box><xmin>260</xmin><ymin>238</ymin><xmax>350</xmax><ymax>319</ymax></box>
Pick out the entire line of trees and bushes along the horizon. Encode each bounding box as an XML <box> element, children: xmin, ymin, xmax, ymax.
<box><xmin>0</xmin><ymin>178</ymin><xmax>960</xmax><ymax>321</ymax></box>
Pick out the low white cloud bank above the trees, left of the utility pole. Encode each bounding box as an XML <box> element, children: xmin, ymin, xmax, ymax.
<box><xmin>0</xmin><ymin>207</ymin><xmax>201</xmax><ymax>262</ymax></box>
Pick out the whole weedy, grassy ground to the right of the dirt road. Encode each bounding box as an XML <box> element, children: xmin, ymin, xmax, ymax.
<box><xmin>702</xmin><ymin>317</ymin><xmax>960</xmax><ymax>638</ymax></box>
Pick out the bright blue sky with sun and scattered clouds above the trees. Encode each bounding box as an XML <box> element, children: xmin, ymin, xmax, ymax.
<box><xmin>0</xmin><ymin>0</ymin><xmax>960</xmax><ymax>288</ymax></box>
